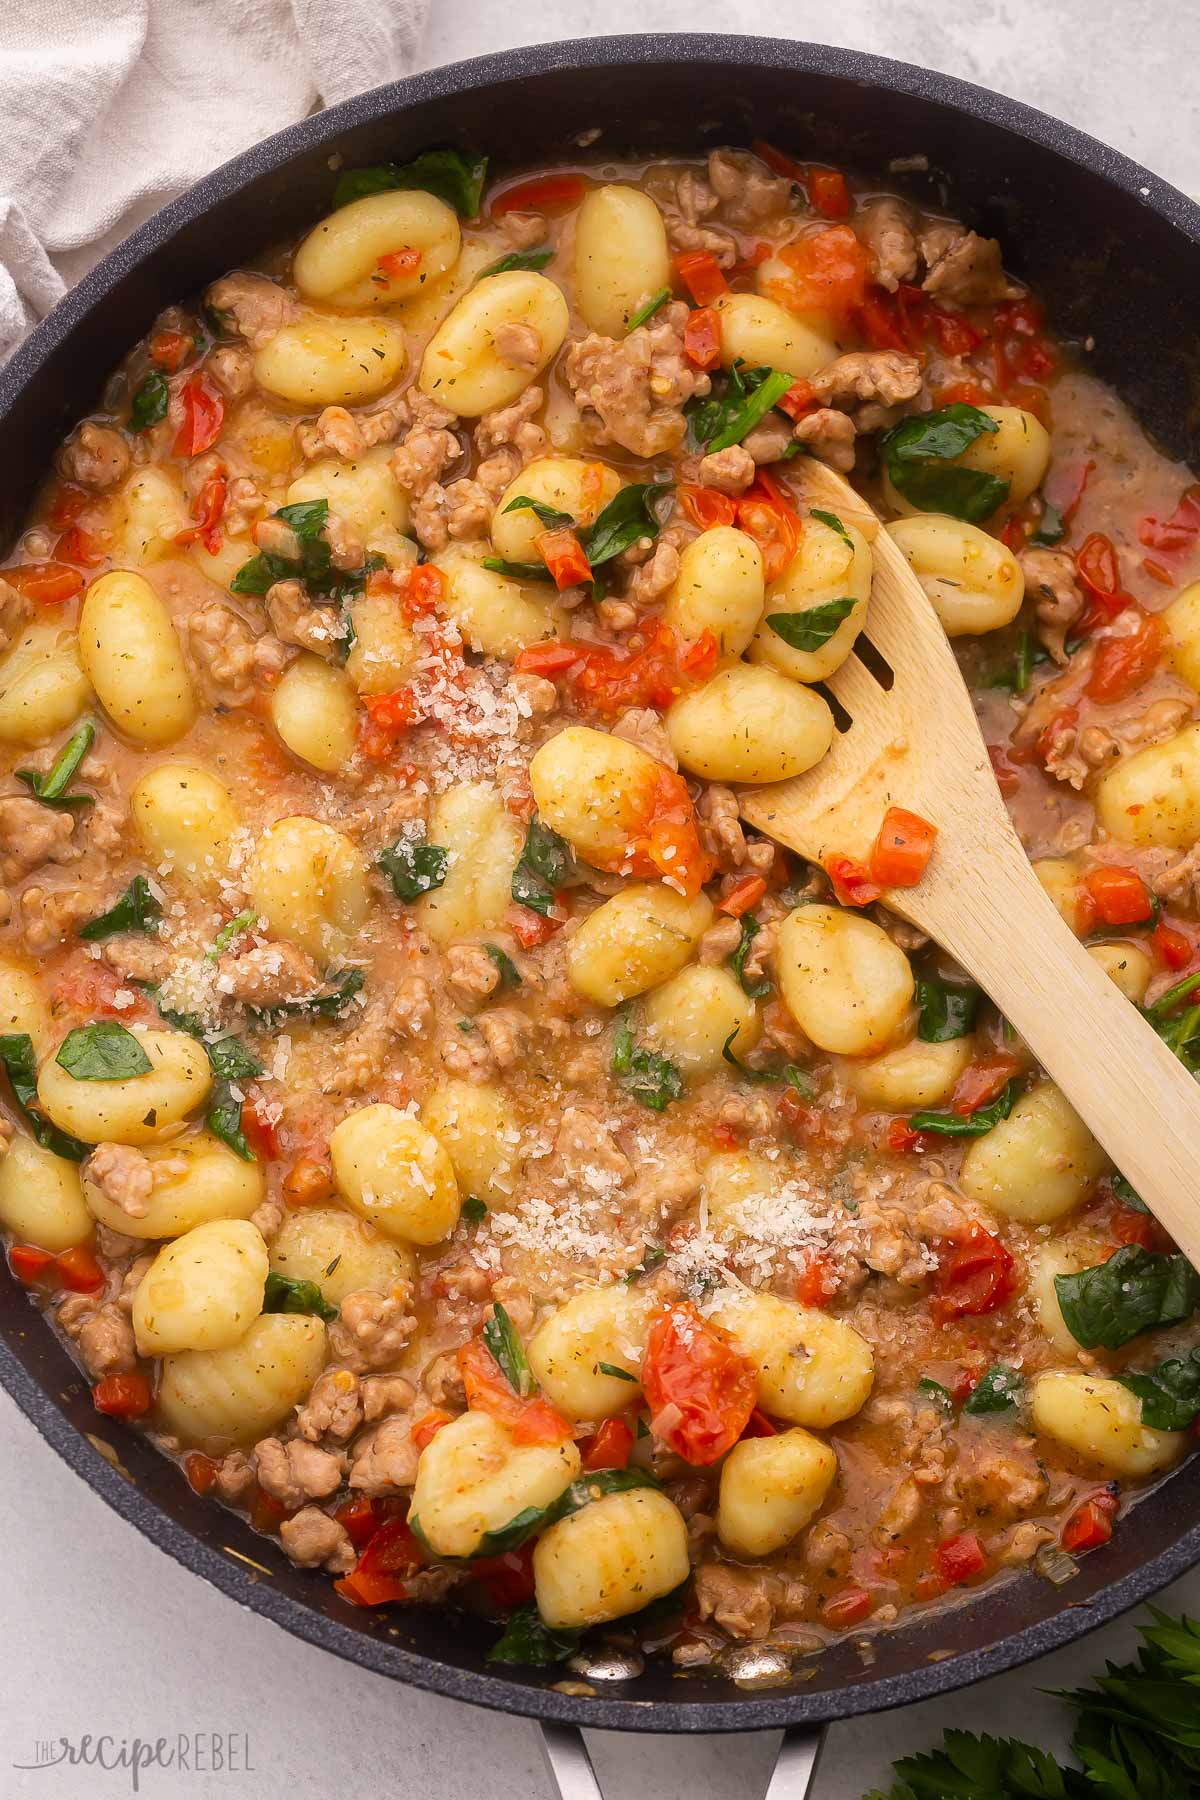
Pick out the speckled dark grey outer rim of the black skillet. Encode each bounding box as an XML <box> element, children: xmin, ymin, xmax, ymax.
<box><xmin>0</xmin><ymin>32</ymin><xmax>1200</xmax><ymax>1733</ymax></box>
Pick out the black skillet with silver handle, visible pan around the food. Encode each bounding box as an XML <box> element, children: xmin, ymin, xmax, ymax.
<box><xmin>0</xmin><ymin>36</ymin><xmax>1200</xmax><ymax>1800</ymax></box>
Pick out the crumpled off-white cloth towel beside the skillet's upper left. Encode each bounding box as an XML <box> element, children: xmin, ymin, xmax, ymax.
<box><xmin>0</xmin><ymin>0</ymin><xmax>430</xmax><ymax>360</ymax></box>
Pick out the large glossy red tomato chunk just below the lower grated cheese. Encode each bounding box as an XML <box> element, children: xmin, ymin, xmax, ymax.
<box><xmin>642</xmin><ymin>1301</ymin><xmax>757</xmax><ymax>1467</ymax></box>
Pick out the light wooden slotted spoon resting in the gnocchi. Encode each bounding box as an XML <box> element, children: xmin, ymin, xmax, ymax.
<box><xmin>739</xmin><ymin>463</ymin><xmax>1200</xmax><ymax>1265</ymax></box>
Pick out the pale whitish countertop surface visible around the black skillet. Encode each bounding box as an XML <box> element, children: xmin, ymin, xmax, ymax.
<box><xmin>0</xmin><ymin>0</ymin><xmax>1200</xmax><ymax>1800</ymax></box>
